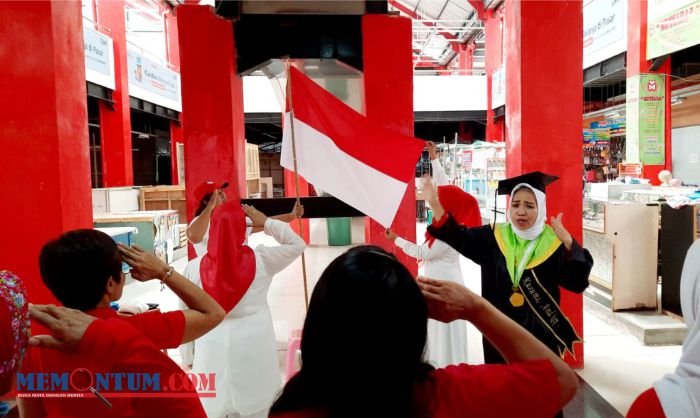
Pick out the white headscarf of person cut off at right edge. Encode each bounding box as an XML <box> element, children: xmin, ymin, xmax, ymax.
<box><xmin>654</xmin><ymin>241</ymin><xmax>700</xmax><ymax>418</ymax></box>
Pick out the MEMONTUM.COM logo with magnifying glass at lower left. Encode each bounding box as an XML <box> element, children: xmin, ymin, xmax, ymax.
<box><xmin>17</xmin><ymin>368</ymin><xmax>216</xmax><ymax>404</ymax></box>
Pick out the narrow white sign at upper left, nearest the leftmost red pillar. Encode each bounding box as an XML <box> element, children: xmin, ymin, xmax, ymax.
<box><xmin>83</xmin><ymin>26</ymin><xmax>114</xmax><ymax>90</ymax></box>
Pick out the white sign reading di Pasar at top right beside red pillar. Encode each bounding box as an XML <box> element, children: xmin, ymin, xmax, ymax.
<box><xmin>583</xmin><ymin>0</ymin><xmax>636</xmax><ymax>68</ymax></box>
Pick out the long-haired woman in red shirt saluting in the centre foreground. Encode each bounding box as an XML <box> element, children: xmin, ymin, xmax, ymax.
<box><xmin>270</xmin><ymin>246</ymin><xmax>578</xmax><ymax>418</ymax></box>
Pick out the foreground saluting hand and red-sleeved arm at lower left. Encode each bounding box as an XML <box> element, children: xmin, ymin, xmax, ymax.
<box><xmin>23</xmin><ymin>305</ymin><xmax>206</xmax><ymax>418</ymax></box>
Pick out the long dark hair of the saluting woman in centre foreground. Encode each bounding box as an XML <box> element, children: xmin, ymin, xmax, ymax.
<box><xmin>271</xmin><ymin>246</ymin><xmax>432</xmax><ymax>417</ymax></box>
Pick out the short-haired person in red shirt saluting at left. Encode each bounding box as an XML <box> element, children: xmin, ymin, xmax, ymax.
<box><xmin>19</xmin><ymin>229</ymin><xmax>225</xmax><ymax>417</ymax></box>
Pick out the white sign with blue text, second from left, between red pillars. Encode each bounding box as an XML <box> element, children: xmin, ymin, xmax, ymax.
<box><xmin>127</xmin><ymin>48</ymin><xmax>182</xmax><ymax>112</ymax></box>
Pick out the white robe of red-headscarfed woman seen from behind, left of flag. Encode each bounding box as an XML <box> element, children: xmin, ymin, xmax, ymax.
<box><xmin>181</xmin><ymin>218</ymin><xmax>306</xmax><ymax>418</ymax></box>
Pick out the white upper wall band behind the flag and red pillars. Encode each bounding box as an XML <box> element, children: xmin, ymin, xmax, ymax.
<box><xmin>243</xmin><ymin>76</ymin><xmax>486</xmax><ymax>113</ymax></box>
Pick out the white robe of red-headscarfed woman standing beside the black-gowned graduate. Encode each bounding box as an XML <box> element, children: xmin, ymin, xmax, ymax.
<box><xmin>395</xmin><ymin>238</ymin><xmax>468</xmax><ymax>368</ymax></box>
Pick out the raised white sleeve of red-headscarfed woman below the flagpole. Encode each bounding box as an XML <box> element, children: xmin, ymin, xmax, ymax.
<box><xmin>255</xmin><ymin>218</ymin><xmax>306</xmax><ymax>276</ymax></box>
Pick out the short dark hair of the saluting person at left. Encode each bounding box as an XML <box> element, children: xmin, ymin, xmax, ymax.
<box><xmin>39</xmin><ymin>229</ymin><xmax>122</xmax><ymax>311</ymax></box>
